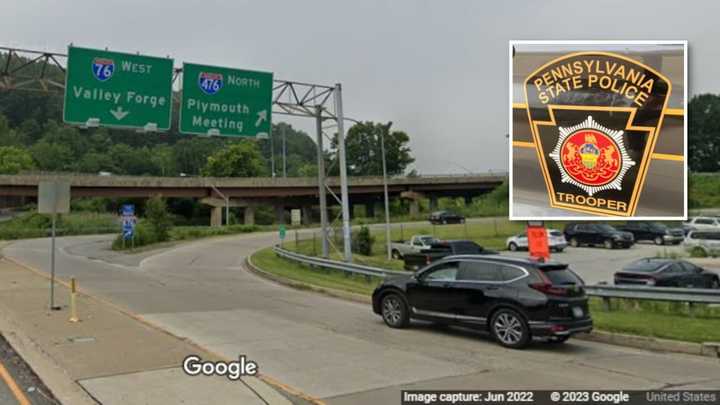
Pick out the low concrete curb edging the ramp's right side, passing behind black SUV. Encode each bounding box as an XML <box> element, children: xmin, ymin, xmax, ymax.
<box><xmin>245</xmin><ymin>251</ymin><xmax>720</xmax><ymax>358</ymax></box>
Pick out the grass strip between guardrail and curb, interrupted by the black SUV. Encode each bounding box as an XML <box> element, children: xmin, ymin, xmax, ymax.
<box><xmin>252</xmin><ymin>248</ymin><xmax>720</xmax><ymax>343</ymax></box>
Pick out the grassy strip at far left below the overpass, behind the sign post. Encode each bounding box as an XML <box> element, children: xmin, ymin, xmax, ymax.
<box><xmin>0</xmin><ymin>212</ymin><xmax>120</xmax><ymax>240</ymax></box>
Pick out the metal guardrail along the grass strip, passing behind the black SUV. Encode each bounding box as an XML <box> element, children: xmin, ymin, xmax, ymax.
<box><xmin>273</xmin><ymin>246</ymin><xmax>720</xmax><ymax>304</ymax></box>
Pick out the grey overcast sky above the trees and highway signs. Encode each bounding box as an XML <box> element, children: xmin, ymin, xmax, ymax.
<box><xmin>0</xmin><ymin>0</ymin><xmax>720</xmax><ymax>174</ymax></box>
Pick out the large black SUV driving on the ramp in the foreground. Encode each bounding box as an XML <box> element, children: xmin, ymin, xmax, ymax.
<box><xmin>372</xmin><ymin>255</ymin><xmax>593</xmax><ymax>348</ymax></box>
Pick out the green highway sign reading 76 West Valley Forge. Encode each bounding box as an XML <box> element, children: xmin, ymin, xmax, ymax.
<box><xmin>63</xmin><ymin>46</ymin><xmax>173</xmax><ymax>131</ymax></box>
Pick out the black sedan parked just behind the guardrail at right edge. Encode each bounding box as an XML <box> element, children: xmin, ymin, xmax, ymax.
<box><xmin>615</xmin><ymin>258</ymin><xmax>720</xmax><ymax>288</ymax></box>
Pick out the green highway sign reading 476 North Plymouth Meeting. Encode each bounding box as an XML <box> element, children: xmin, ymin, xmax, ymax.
<box><xmin>180</xmin><ymin>63</ymin><xmax>273</xmax><ymax>137</ymax></box>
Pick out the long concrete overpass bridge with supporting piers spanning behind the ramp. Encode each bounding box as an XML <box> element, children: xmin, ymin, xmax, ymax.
<box><xmin>0</xmin><ymin>173</ymin><xmax>507</xmax><ymax>225</ymax></box>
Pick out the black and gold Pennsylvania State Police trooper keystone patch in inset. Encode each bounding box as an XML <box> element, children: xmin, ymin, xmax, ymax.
<box><xmin>524</xmin><ymin>51</ymin><xmax>672</xmax><ymax>216</ymax></box>
